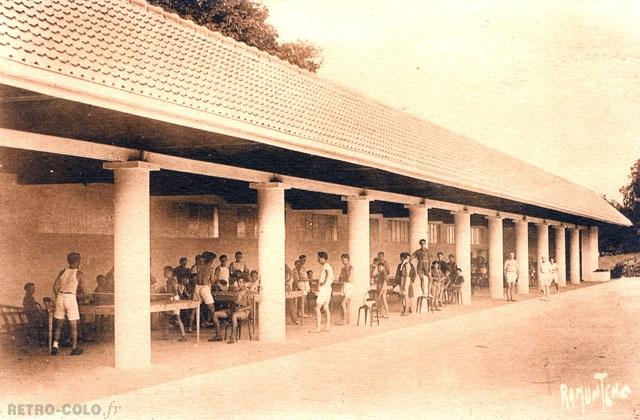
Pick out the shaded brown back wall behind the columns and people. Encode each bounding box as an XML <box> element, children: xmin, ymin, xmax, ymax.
<box><xmin>0</xmin><ymin>174</ymin><xmax>490</xmax><ymax>305</ymax></box>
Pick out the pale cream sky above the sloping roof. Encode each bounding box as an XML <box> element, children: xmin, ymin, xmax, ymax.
<box><xmin>261</xmin><ymin>0</ymin><xmax>640</xmax><ymax>200</ymax></box>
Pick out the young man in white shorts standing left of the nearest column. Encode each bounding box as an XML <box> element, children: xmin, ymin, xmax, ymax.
<box><xmin>51</xmin><ymin>252</ymin><xmax>84</xmax><ymax>356</ymax></box>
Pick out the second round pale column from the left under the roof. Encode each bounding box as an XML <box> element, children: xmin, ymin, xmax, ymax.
<box><xmin>251</xmin><ymin>182</ymin><xmax>287</xmax><ymax>342</ymax></box>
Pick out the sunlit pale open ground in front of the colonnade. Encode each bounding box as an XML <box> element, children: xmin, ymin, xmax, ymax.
<box><xmin>0</xmin><ymin>279</ymin><xmax>640</xmax><ymax>418</ymax></box>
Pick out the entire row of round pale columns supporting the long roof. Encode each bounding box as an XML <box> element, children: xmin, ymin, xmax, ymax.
<box><xmin>104</xmin><ymin>161</ymin><xmax>598</xmax><ymax>369</ymax></box>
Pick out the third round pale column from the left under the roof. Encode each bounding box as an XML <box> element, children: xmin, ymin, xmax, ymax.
<box><xmin>342</xmin><ymin>196</ymin><xmax>371</xmax><ymax>322</ymax></box>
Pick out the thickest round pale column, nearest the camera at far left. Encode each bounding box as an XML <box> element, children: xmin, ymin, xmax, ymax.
<box><xmin>104</xmin><ymin>161</ymin><xmax>155</xmax><ymax>369</ymax></box>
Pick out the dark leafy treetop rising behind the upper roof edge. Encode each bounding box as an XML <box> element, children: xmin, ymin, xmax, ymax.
<box><xmin>147</xmin><ymin>0</ymin><xmax>322</xmax><ymax>73</ymax></box>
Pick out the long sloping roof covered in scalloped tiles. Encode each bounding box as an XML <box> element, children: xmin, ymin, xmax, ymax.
<box><xmin>0</xmin><ymin>0</ymin><xmax>629</xmax><ymax>224</ymax></box>
